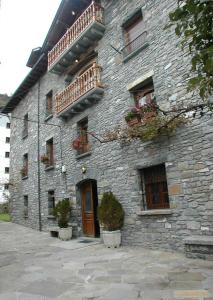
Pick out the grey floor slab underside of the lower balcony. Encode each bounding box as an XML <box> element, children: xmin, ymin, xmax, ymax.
<box><xmin>57</xmin><ymin>87</ymin><xmax>104</xmax><ymax>118</ymax></box>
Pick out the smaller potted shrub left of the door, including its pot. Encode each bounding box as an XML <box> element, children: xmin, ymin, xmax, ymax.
<box><xmin>53</xmin><ymin>199</ymin><xmax>72</xmax><ymax>241</ymax></box>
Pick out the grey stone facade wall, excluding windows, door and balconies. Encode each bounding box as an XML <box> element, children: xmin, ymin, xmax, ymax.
<box><xmin>7</xmin><ymin>0</ymin><xmax>213</xmax><ymax>250</ymax></box>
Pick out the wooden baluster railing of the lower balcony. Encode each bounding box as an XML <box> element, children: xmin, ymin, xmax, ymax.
<box><xmin>55</xmin><ymin>63</ymin><xmax>103</xmax><ymax>115</ymax></box>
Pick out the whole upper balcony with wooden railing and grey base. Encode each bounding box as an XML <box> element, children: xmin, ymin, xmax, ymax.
<box><xmin>48</xmin><ymin>2</ymin><xmax>105</xmax><ymax>74</ymax></box>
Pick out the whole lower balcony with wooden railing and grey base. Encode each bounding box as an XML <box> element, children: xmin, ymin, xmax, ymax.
<box><xmin>55</xmin><ymin>63</ymin><xmax>104</xmax><ymax>118</ymax></box>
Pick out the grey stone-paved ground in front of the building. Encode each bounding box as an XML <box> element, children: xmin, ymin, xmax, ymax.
<box><xmin>0</xmin><ymin>222</ymin><xmax>213</xmax><ymax>300</ymax></box>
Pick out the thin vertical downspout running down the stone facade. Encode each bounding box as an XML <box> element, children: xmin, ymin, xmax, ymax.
<box><xmin>37</xmin><ymin>78</ymin><xmax>42</xmax><ymax>231</ymax></box>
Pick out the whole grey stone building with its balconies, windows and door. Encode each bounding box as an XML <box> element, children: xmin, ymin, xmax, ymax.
<box><xmin>4</xmin><ymin>0</ymin><xmax>213</xmax><ymax>250</ymax></box>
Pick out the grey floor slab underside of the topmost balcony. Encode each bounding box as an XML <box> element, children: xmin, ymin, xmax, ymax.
<box><xmin>49</xmin><ymin>21</ymin><xmax>105</xmax><ymax>75</ymax></box>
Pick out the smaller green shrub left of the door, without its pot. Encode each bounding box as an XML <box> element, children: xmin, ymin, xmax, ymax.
<box><xmin>53</xmin><ymin>199</ymin><xmax>71</xmax><ymax>228</ymax></box>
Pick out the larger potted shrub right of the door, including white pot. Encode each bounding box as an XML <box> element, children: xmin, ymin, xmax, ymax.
<box><xmin>98</xmin><ymin>192</ymin><xmax>124</xmax><ymax>248</ymax></box>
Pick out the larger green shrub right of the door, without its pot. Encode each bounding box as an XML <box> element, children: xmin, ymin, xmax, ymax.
<box><xmin>98</xmin><ymin>192</ymin><xmax>124</xmax><ymax>231</ymax></box>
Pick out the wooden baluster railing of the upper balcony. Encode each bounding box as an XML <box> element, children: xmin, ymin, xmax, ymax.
<box><xmin>48</xmin><ymin>3</ymin><xmax>104</xmax><ymax>69</ymax></box>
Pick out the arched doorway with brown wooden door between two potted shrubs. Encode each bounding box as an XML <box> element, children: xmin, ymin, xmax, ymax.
<box><xmin>79</xmin><ymin>179</ymin><xmax>100</xmax><ymax>237</ymax></box>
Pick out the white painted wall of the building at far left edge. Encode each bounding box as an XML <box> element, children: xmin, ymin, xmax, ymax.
<box><xmin>0</xmin><ymin>115</ymin><xmax>10</xmax><ymax>203</ymax></box>
